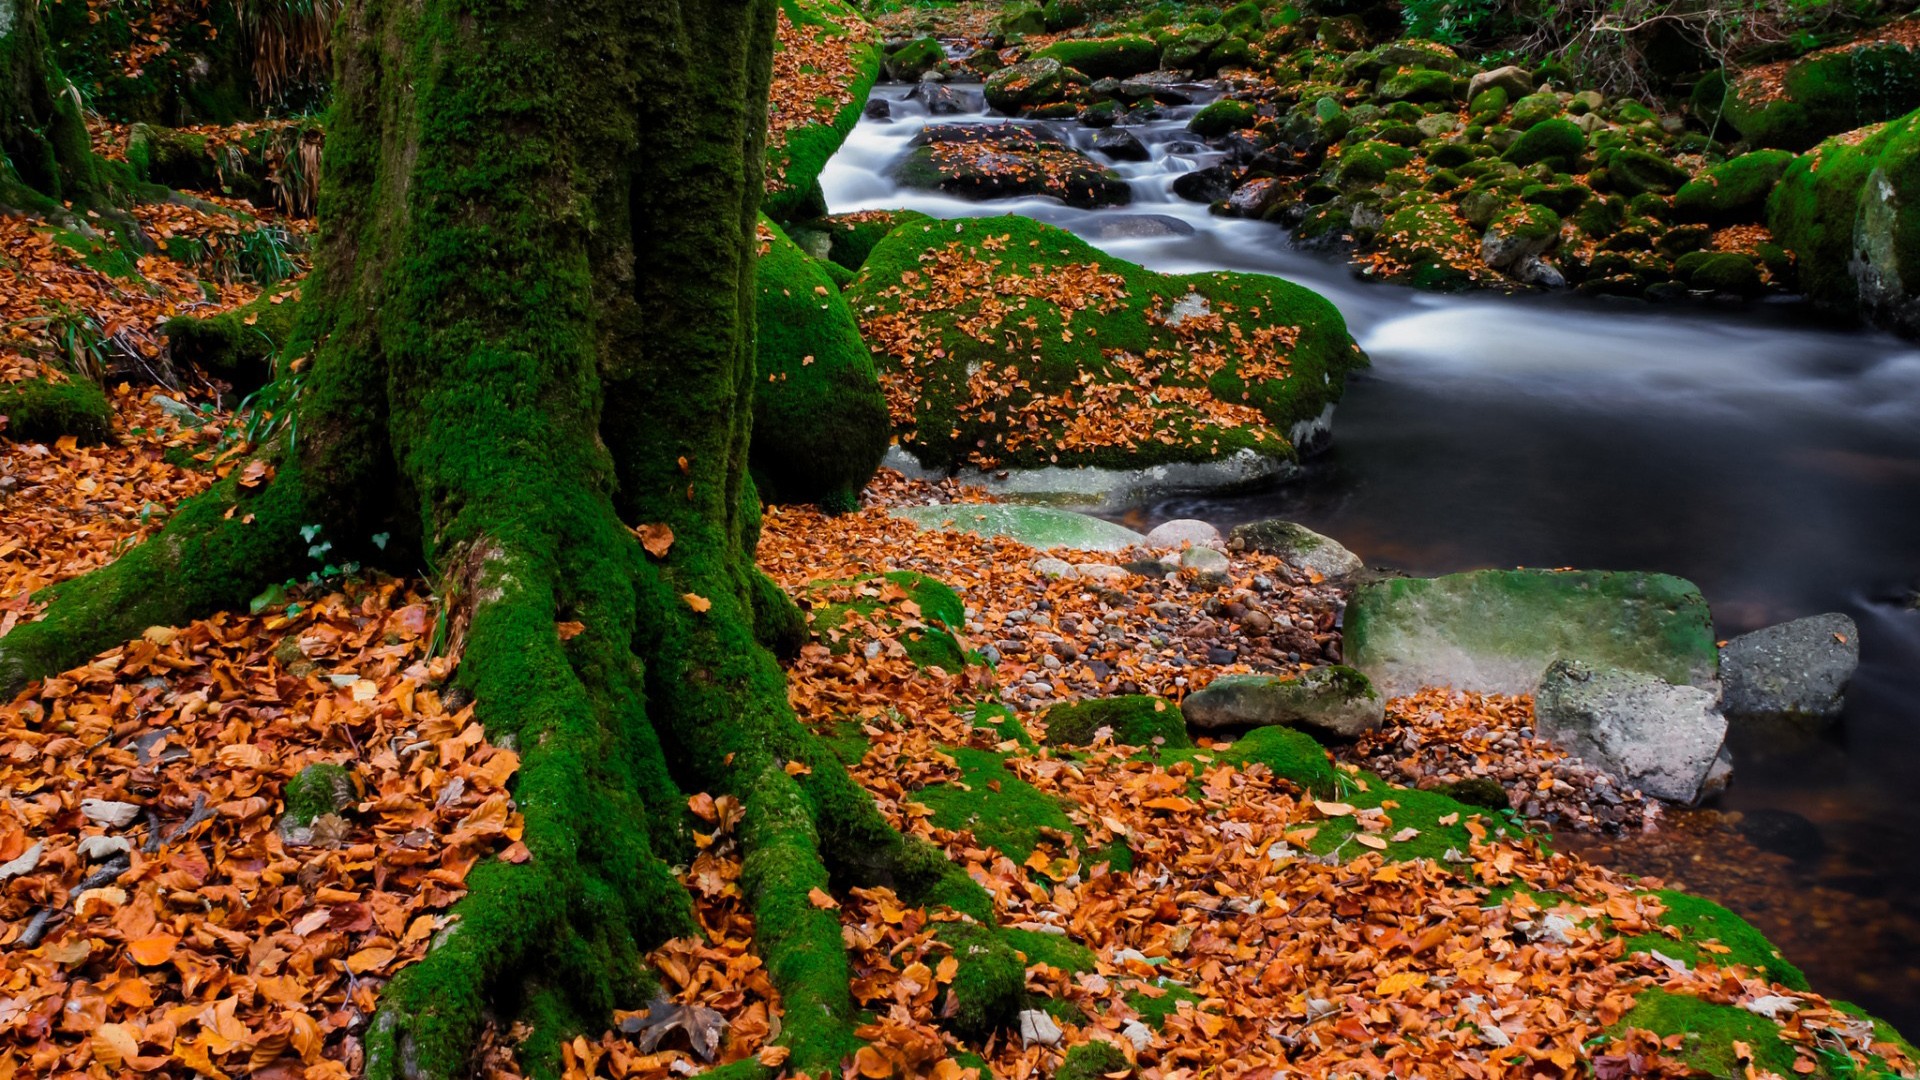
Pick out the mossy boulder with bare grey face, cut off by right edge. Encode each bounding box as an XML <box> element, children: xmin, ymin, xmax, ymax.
<box><xmin>1766</xmin><ymin>111</ymin><xmax>1920</xmax><ymax>336</ymax></box>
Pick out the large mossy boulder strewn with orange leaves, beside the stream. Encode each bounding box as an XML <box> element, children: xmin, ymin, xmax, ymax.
<box><xmin>847</xmin><ymin>217</ymin><xmax>1365</xmax><ymax>469</ymax></box>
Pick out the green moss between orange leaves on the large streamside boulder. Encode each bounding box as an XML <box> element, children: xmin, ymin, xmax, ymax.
<box><xmin>847</xmin><ymin>217</ymin><xmax>1365</xmax><ymax>469</ymax></box>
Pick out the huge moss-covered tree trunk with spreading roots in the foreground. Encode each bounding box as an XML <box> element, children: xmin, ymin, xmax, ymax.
<box><xmin>0</xmin><ymin>0</ymin><xmax>1020</xmax><ymax>1076</ymax></box>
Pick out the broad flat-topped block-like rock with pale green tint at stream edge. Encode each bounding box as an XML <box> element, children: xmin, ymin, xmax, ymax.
<box><xmin>1344</xmin><ymin>571</ymin><xmax>1720</xmax><ymax>698</ymax></box>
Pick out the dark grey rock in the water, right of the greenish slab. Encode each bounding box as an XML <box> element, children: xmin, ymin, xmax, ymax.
<box><xmin>1720</xmin><ymin>613</ymin><xmax>1860</xmax><ymax>724</ymax></box>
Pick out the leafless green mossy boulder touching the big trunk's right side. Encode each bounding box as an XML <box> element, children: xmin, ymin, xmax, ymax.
<box><xmin>751</xmin><ymin>217</ymin><xmax>889</xmax><ymax>509</ymax></box>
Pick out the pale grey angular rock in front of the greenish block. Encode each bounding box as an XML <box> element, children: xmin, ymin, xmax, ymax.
<box><xmin>1534</xmin><ymin>659</ymin><xmax>1730</xmax><ymax>803</ymax></box>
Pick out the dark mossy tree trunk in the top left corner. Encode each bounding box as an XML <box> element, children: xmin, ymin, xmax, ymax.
<box><xmin>0</xmin><ymin>0</ymin><xmax>102</xmax><ymax>217</ymax></box>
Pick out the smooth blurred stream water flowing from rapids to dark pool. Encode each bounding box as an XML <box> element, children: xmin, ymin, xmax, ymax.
<box><xmin>822</xmin><ymin>86</ymin><xmax>1920</xmax><ymax>1034</ymax></box>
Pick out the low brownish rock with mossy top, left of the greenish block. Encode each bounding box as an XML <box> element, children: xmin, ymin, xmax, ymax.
<box><xmin>1181</xmin><ymin>665</ymin><xmax>1386</xmax><ymax>738</ymax></box>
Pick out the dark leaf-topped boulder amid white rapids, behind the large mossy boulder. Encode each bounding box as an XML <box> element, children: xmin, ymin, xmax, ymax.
<box><xmin>893</xmin><ymin>123</ymin><xmax>1133</xmax><ymax>209</ymax></box>
